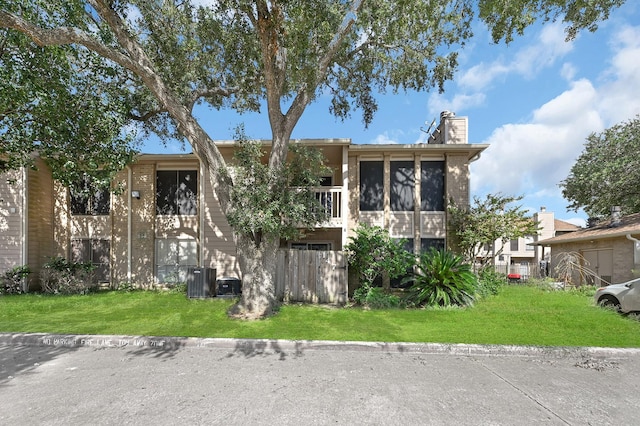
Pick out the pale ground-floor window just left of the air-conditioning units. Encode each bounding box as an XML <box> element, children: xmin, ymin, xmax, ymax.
<box><xmin>156</xmin><ymin>239</ymin><xmax>198</xmax><ymax>283</ymax></box>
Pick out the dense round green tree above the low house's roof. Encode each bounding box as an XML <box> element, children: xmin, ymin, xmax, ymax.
<box><xmin>560</xmin><ymin>116</ymin><xmax>640</xmax><ymax>217</ymax></box>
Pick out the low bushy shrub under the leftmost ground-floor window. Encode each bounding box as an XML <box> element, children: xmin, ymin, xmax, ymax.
<box><xmin>40</xmin><ymin>257</ymin><xmax>97</xmax><ymax>294</ymax></box>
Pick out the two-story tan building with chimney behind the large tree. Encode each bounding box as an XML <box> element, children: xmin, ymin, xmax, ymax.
<box><xmin>5</xmin><ymin>113</ymin><xmax>487</xmax><ymax>292</ymax></box>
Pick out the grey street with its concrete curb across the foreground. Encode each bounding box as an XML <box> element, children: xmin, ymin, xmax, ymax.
<box><xmin>0</xmin><ymin>334</ymin><xmax>640</xmax><ymax>425</ymax></box>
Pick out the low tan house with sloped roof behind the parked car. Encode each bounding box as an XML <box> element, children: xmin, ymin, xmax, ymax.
<box><xmin>536</xmin><ymin>213</ymin><xmax>640</xmax><ymax>286</ymax></box>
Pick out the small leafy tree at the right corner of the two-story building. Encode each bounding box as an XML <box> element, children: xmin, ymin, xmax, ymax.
<box><xmin>448</xmin><ymin>194</ymin><xmax>539</xmax><ymax>268</ymax></box>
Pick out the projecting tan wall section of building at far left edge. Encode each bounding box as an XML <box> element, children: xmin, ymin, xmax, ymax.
<box><xmin>0</xmin><ymin>160</ymin><xmax>54</xmax><ymax>287</ymax></box>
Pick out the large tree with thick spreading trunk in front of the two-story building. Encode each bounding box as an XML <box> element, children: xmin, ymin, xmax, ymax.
<box><xmin>0</xmin><ymin>0</ymin><xmax>624</xmax><ymax>316</ymax></box>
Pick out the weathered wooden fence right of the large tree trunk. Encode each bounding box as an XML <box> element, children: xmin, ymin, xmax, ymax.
<box><xmin>276</xmin><ymin>250</ymin><xmax>348</xmax><ymax>304</ymax></box>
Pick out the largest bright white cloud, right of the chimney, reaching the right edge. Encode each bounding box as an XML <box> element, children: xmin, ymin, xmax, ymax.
<box><xmin>471</xmin><ymin>22</ymin><xmax>640</xmax><ymax>216</ymax></box>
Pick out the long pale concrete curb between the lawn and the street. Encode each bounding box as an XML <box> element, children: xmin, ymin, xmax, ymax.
<box><xmin>0</xmin><ymin>333</ymin><xmax>640</xmax><ymax>359</ymax></box>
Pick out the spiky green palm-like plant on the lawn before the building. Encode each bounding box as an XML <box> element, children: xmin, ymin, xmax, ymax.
<box><xmin>408</xmin><ymin>249</ymin><xmax>478</xmax><ymax>306</ymax></box>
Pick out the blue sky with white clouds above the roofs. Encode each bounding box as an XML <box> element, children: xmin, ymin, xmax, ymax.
<box><xmin>142</xmin><ymin>0</ymin><xmax>640</xmax><ymax>226</ymax></box>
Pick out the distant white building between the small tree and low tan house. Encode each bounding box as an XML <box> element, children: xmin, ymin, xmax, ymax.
<box><xmin>484</xmin><ymin>207</ymin><xmax>581</xmax><ymax>279</ymax></box>
